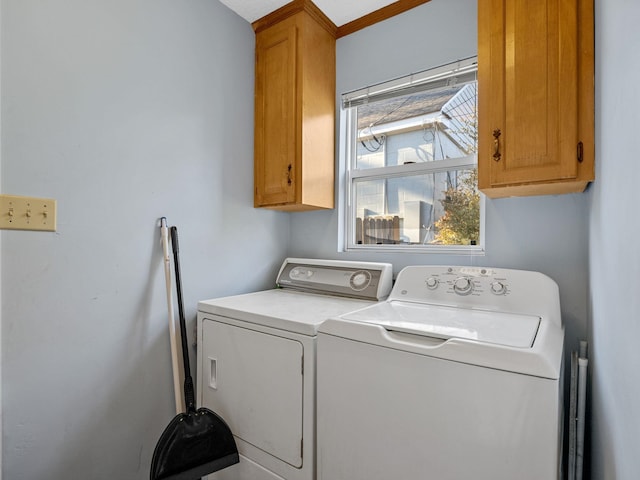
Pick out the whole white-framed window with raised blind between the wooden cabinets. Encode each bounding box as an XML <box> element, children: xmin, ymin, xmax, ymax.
<box><xmin>341</xmin><ymin>58</ymin><xmax>484</xmax><ymax>254</ymax></box>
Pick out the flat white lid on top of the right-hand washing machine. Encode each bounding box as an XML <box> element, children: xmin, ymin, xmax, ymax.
<box><xmin>342</xmin><ymin>301</ymin><xmax>540</xmax><ymax>348</ymax></box>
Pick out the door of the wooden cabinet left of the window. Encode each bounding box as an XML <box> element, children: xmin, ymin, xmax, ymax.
<box><xmin>254</xmin><ymin>22</ymin><xmax>299</xmax><ymax>206</ymax></box>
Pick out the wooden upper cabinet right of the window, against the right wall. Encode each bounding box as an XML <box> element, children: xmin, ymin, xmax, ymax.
<box><xmin>478</xmin><ymin>0</ymin><xmax>594</xmax><ymax>197</ymax></box>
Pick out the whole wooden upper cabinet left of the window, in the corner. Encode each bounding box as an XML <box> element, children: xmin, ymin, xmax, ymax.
<box><xmin>253</xmin><ymin>0</ymin><xmax>336</xmax><ymax>211</ymax></box>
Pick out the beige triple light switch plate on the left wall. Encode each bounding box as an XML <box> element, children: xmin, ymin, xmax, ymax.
<box><xmin>0</xmin><ymin>194</ymin><xmax>56</xmax><ymax>232</ymax></box>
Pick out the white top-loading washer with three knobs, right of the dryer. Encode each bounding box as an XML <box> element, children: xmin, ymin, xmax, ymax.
<box><xmin>317</xmin><ymin>266</ymin><xmax>564</xmax><ymax>480</ymax></box>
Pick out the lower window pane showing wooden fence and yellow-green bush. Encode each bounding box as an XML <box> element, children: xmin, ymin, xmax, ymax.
<box><xmin>353</xmin><ymin>169</ymin><xmax>480</xmax><ymax>245</ymax></box>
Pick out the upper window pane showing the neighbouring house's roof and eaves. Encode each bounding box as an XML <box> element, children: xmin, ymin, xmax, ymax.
<box><xmin>355</xmin><ymin>82</ymin><xmax>477</xmax><ymax>169</ymax></box>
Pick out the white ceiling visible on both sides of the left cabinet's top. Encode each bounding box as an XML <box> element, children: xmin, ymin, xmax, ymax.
<box><xmin>220</xmin><ymin>0</ymin><xmax>394</xmax><ymax>27</ymax></box>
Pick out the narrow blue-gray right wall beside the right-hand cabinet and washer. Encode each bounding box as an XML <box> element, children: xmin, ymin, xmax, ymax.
<box><xmin>589</xmin><ymin>0</ymin><xmax>640</xmax><ymax>480</ymax></box>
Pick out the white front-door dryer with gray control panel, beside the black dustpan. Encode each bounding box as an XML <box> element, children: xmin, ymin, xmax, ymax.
<box><xmin>197</xmin><ymin>258</ymin><xmax>392</xmax><ymax>480</ymax></box>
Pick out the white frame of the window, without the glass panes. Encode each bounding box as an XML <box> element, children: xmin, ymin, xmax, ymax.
<box><xmin>339</xmin><ymin>57</ymin><xmax>486</xmax><ymax>255</ymax></box>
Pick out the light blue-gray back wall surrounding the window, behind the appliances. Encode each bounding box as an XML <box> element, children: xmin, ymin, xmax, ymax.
<box><xmin>291</xmin><ymin>0</ymin><xmax>589</xmax><ymax>350</ymax></box>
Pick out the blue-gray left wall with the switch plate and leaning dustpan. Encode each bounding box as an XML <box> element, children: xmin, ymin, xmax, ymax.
<box><xmin>1</xmin><ymin>0</ymin><xmax>289</xmax><ymax>480</ymax></box>
